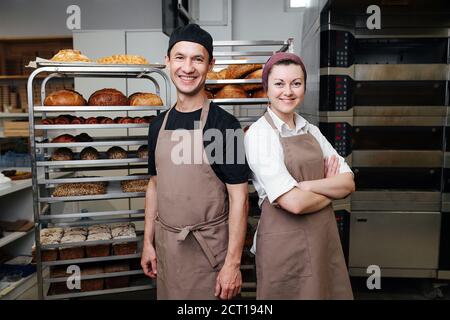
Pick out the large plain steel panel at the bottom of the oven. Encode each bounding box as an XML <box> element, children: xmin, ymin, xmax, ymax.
<box><xmin>349</xmin><ymin>211</ymin><xmax>441</xmax><ymax>270</ymax></box>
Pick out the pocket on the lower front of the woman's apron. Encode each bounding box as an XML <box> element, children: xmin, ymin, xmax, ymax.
<box><xmin>256</xmin><ymin>229</ymin><xmax>312</xmax><ymax>287</ymax></box>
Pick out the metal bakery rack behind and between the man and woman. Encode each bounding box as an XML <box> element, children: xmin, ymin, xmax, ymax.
<box><xmin>206</xmin><ymin>38</ymin><xmax>294</xmax><ymax>298</ymax></box>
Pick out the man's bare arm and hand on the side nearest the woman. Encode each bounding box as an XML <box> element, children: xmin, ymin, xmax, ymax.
<box><xmin>215</xmin><ymin>182</ymin><xmax>248</xmax><ymax>299</ymax></box>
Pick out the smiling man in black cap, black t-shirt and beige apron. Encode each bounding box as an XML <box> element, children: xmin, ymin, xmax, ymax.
<box><xmin>141</xmin><ymin>24</ymin><xmax>249</xmax><ymax>299</ymax></box>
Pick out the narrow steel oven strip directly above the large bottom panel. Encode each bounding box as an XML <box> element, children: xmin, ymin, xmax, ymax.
<box><xmin>351</xmin><ymin>190</ymin><xmax>441</xmax><ymax>211</ymax></box>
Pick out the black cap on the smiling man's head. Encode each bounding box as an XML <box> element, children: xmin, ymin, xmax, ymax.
<box><xmin>167</xmin><ymin>23</ymin><xmax>213</xmax><ymax>61</ymax></box>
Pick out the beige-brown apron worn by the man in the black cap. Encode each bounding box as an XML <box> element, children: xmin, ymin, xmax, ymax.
<box><xmin>155</xmin><ymin>100</ymin><xmax>228</xmax><ymax>299</ymax></box>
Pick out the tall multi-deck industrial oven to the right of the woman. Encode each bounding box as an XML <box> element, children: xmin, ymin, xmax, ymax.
<box><xmin>299</xmin><ymin>0</ymin><xmax>450</xmax><ymax>279</ymax></box>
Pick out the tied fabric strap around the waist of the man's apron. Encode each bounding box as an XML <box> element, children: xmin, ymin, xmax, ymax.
<box><xmin>156</xmin><ymin>214</ymin><xmax>228</xmax><ymax>268</ymax></box>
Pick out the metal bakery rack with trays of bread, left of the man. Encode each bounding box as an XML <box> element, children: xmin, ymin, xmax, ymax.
<box><xmin>27</xmin><ymin>62</ymin><xmax>171</xmax><ymax>300</ymax></box>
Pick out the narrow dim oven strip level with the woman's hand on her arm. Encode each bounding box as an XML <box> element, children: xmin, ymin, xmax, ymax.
<box><xmin>352</xmin><ymin>150</ymin><xmax>443</xmax><ymax>168</ymax></box>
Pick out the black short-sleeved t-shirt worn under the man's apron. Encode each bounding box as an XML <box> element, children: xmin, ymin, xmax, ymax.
<box><xmin>148</xmin><ymin>103</ymin><xmax>250</xmax><ymax>184</ymax></box>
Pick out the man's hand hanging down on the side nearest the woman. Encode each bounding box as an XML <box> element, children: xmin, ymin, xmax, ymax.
<box><xmin>214</xmin><ymin>264</ymin><xmax>242</xmax><ymax>300</ymax></box>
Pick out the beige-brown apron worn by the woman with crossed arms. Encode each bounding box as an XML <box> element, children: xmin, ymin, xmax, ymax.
<box><xmin>256</xmin><ymin>112</ymin><xmax>353</xmax><ymax>299</ymax></box>
